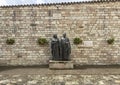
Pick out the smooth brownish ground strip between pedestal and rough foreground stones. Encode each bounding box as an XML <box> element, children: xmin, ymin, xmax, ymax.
<box><xmin>0</xmin><ymin>66</ymin><xmax>120</xmax><ymax>75</ymax></box>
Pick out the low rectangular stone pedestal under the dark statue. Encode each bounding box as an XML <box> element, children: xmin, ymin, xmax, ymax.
<box><xmin>49</xmin><ymin>60</ymin><xmax>74</xmax><ymax>69</ymax></box>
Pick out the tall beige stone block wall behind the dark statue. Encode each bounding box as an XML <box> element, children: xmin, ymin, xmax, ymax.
<box><xmin>0</xmin><ymin>1</ymin><xmax>120</xmax><ymax>65</ymax></box>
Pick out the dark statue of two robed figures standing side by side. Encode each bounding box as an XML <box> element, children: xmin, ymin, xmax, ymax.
<box><xmin>51</xmin><ymin>33</ymin><xmax>71</xmax><ymax>61</ymax></box>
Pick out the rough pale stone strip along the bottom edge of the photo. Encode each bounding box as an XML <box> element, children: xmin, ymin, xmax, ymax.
<box><xmin>0</xmin><ymin>75</ymin><xmax>120</xmax><ymax>85</ymax></box>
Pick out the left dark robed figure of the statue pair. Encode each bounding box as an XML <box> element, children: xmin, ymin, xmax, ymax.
<box><xmin>51</xmin><ymin>34</ymin><xmax>60</xmax><ymax>61</ymax></box>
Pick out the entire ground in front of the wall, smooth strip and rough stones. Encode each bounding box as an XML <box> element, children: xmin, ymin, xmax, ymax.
<box><xmin>0</xmin><ymin>67</ymin><xmax>120</xmax><ymax>85</ymax></box>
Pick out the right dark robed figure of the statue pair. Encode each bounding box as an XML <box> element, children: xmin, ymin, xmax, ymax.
<box><xmin>60</xmin><ymin>33</ymin><xmax>71</xmax><ymax>61</ymax></box>
